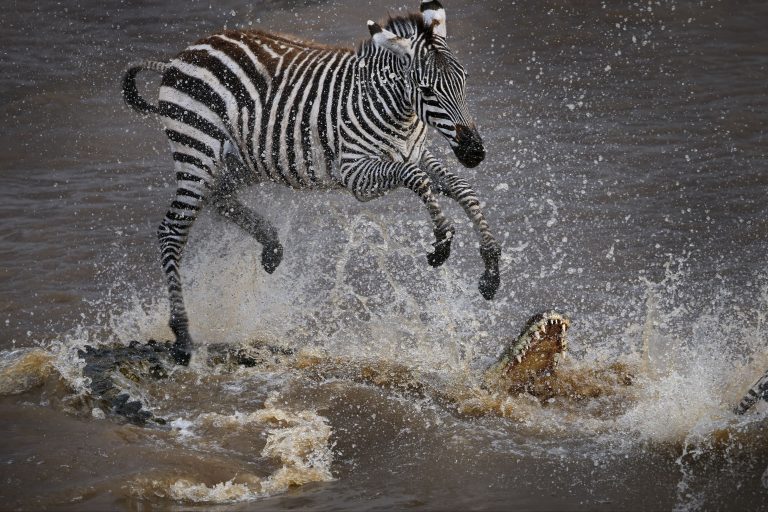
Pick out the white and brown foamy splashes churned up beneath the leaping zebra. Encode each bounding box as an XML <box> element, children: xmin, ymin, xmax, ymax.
<box><xmin>0</xmin><ymin>207</ymin><xmax>768</xmax><ymax>509</ymax></box>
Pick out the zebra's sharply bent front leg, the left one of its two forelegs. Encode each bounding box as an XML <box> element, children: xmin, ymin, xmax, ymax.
<box><xmin>341</xmin><ymin>158</ymin><xmax>456</xmax><ymax>267</ymax></box>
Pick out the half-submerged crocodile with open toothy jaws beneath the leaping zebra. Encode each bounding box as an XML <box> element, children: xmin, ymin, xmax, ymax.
<box><xmin>78</xmin><ymin>311</ymin><xmax>570</xmax><ymax>425</ymax></box>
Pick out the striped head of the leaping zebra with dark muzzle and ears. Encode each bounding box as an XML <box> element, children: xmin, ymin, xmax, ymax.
<box><xmin>368</xmin><ymin>0</ymin><xmax>485</xmax><ymax>167</ymax></box>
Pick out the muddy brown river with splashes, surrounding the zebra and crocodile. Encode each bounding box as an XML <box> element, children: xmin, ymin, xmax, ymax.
<box><xmin>0</xmin><ymin>0</ymin><xmax>768</xmax><ymax>511</ymax></box>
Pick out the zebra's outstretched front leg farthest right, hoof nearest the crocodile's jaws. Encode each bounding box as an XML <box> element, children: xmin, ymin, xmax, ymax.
<box><xmin>421</xmin><ymin>151</ymin><xmax>501</xmax><ymax>300</ymax></box>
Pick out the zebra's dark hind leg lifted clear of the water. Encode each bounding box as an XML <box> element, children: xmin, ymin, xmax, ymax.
<box><xmin>211</xmin><ymin>190</ymin><xmax>283</xmax><ymax>274</ymax></box>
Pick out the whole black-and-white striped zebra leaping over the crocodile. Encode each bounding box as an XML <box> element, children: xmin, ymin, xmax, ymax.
<box><xmin>122</xmin><ymin>0</ymin><xmax>501</xmax><ymax>364</ymax></box>
